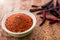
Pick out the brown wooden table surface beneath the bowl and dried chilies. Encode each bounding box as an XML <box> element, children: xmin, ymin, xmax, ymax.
<box><xmin>0</xmin><ymin>0</ymin><xmax>60</xmax><ymax>40</ymax></box>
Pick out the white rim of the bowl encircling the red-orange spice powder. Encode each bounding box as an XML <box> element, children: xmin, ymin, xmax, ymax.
<box><xmin>1</xmin><ymin>10</ymin><xmax>36</xmax><ymax>34</ymax></box>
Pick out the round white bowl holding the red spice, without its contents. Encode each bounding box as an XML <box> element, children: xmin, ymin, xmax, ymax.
<box><xmin>1</xmin><ymin>10</ymin><xmax>36</xmax><ymax>37</ymax></box>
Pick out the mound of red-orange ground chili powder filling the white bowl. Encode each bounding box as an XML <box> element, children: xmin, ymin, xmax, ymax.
<box><xmin>5</xmin><ymin>13</ymin><xmax>33</xmax><ymax>32</ymax></box>
